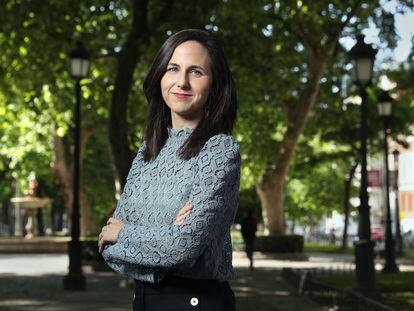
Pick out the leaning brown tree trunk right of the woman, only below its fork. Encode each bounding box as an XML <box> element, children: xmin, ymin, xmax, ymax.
<box><xmin>256</xmin><ymin>52</ymin><xmax>325</xmax><ymax>235</ymax></box>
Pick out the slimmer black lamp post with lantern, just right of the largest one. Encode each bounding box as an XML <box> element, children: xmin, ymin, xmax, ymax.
<box><xmin>378</xmin><ymin>91</ymin><xmax>399</xmax><ymax>273</ymax></box>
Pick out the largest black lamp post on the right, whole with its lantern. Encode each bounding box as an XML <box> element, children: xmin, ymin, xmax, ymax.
<box><xmin>349</xmin><ymin>35</ymin><xmax>378</xmax><ymax>297</ymax></box>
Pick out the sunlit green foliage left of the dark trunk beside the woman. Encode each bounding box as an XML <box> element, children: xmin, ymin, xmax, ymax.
<box><xmin>0</xmin><ymin>1</ymin><xmax>131</xmax><ymax>227</ymax></box>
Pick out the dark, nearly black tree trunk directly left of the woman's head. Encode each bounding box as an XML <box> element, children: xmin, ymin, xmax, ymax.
<box><xmin>109</xmin><ymin>0</ymin><xmax>148</xmax><ymax>197</ymax></box>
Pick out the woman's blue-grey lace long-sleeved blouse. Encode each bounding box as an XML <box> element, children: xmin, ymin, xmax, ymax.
<box><xmin>102</xmin><ymin>128</ymin><xmax>241</xmax><ymax>283</ymax></box>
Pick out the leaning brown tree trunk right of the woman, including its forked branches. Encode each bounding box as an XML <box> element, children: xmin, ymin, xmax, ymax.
<box><xmin>256</xmin><ymin>1</ymin><xmax>360</xmax><ymax>234</ymax></box>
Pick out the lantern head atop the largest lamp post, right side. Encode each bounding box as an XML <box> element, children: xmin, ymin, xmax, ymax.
<box><xmin>348</xmin><ymin>35</ymin><xmax>377</xmax><ymax>86</ymax></box>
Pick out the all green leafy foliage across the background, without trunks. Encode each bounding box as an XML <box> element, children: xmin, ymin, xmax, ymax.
<box><xmin>0</xmin><ymin>0</ymin><xmax>414</xmax><ymax>230</ymax></box>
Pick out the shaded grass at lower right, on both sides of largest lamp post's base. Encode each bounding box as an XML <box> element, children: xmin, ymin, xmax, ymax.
<box><xmin>313</xmin><ymin>272</ymin><xmax>414</xmax><ymax>310</ymax></box>
